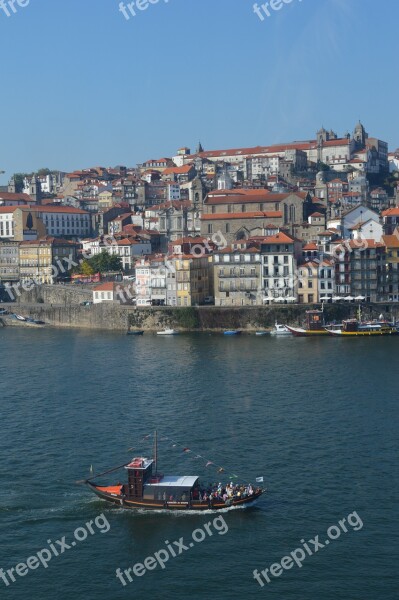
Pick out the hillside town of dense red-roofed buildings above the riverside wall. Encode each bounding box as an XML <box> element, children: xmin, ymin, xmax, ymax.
<box><xmin>0</xmin><ymin>122</ymin><xmax>399</xmax><ymax>307</ymax></box>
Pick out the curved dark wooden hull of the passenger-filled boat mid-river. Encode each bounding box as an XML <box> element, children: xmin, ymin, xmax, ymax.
<box><xmin>86</xmin><ymin>481</ymin><xmax>265</xmax><ymax>512</ymax></box>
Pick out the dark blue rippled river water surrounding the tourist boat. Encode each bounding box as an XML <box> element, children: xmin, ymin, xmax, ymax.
<box><xmin>0</xmin><ymin>328</ymin><xmax>399</xmax><ymax>600</ymax></box>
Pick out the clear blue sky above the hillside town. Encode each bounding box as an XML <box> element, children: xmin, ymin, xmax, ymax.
<box><xmin>0</xmin><ymin>0</ymin><xmax>399</xmax><ymax>184</ymax></box>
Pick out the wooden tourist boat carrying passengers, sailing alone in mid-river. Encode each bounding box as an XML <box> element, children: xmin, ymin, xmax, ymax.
<box><xmin>83</xmin><ymin>436</ymin><xmax>265</xmax><ymax>511</ymax></box>
